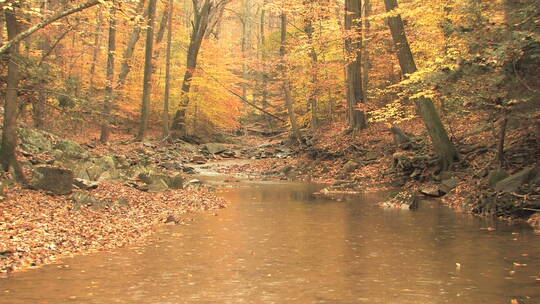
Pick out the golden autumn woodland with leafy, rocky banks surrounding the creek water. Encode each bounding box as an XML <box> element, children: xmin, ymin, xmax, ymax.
<box><xmin>0</xmin><ymin>0</ymin><xmax>540</xmax><ymax>304</ymax></box>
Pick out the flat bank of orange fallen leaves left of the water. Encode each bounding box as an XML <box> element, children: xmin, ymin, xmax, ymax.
<box><xmin>0</xmin><ymin>184</ymin><xmax>226</xmax><ymax>273</ymax></box>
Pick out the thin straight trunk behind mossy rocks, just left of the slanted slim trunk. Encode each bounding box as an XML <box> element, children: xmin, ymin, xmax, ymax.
<box><xmin>99</xmin><ymin>1</ymin><xmax>117</xmax><ymax>143</ymax></box>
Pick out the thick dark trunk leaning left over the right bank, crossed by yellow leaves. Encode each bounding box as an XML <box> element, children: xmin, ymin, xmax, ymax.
<box><xmin>384</xmin><ymin>0</ymin><xmax>459</xmax><ymax>170</ymax></box>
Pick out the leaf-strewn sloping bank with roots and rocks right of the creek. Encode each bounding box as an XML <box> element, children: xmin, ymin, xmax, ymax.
<box><xmin>220</xmin><ymin>117</ymin><xmax>540</xmax><ymax>230</ymax></box>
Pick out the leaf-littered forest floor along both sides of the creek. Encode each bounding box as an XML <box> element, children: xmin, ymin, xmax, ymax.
<box><xmin>0</xmin><ymin>114</ymin><xmax>540</xmax><ymax>274</ymax></box>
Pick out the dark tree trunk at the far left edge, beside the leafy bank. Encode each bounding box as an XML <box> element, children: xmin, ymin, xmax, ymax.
<box><xmin>0</xmin><ymin>8</ymin><xmax>26</xmax><ymax>182</ymax></box>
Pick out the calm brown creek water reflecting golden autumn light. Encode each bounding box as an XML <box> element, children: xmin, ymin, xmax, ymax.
<box><xmin>0</xmin><ymin>183</ymin><xmax>540</xmax><ymax>304</ymax></box>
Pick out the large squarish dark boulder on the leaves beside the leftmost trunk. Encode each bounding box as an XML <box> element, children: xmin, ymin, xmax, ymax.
<box><xmin>30</xmin><ymin>167</ymin><xmax>73</xmax><ymax>195</ymax></box>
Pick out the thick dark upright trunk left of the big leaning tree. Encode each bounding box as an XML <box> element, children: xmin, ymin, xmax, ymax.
<box><xmin>345</xmin><ymin>0</ymin><xmax>367</xmax><ymax>130</ymax></box>
